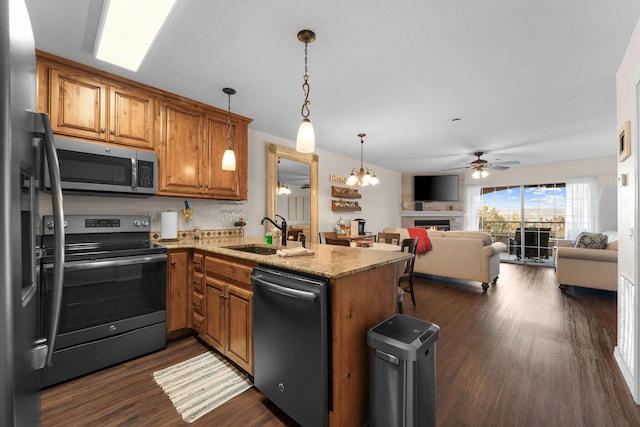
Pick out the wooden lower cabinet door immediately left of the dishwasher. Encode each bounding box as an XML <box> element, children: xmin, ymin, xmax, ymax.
<box><xmin>226</xmin><ymin>285</ymin><xmax>253</xmax><ymax>375</ymax></box>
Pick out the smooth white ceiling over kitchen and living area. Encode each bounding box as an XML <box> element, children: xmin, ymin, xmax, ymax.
<box><xmin>26</xmin><ymin>0</ymin><xmax>640</xmax><ymax>172</ymax></box>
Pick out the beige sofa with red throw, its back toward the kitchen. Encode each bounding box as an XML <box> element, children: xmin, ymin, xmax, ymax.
<box><xmin>383</xmin><ymin>227</ymin><xmax>507</xmax><ymax>291</ymax></box>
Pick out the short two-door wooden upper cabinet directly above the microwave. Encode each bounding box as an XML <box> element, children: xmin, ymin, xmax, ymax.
<box><xmin>49</xmin><ymin>66</ymin><xmax>155</xmax><ymax>149</ymax></box>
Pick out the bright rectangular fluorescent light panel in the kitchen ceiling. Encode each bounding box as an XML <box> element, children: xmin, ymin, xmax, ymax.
<box><xmin>96</xmin><ymin>0</ymin><xmax>176</xmax><ymax>71</ymax></box>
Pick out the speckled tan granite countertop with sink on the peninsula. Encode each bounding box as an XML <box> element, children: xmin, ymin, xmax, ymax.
<box><xmin>157</xmin><ymin>237</ymin><xmax>411</xmax><ymax>279</ymax></box>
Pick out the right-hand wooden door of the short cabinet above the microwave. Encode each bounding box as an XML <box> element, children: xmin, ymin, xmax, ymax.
<box><xmin>108</xmin><ymin>86</ymin><xmax>155</xmax><ymax>149</ymax></box>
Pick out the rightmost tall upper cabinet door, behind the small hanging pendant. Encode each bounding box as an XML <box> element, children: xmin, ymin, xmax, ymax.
<box><xmin>205</xmin><ymin>115</ymin><xmax>247</xmax><ymax>200</ymax></box>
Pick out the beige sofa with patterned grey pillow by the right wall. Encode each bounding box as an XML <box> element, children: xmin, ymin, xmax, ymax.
<box><xmin>555</xmin><ymin>231</ymin><xmax>618</xmax><ymax>293</ymax></box>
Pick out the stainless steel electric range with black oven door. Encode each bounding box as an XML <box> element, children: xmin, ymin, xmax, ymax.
<box><xmin>40</xmin><ymin>215</ymin><xmax>167</xmax><ymax>387</ymax></box>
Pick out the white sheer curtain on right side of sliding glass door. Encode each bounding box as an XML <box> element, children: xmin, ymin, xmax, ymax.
<box><xmin>565</xmin><ymin>176</ymin><xmax>598</xmax><ymax>239</ymax></box>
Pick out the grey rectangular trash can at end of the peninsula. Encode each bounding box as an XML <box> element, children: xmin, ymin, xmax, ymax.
<box><xmin>367</xmin><ymin>314</ymin><xmax>440</xmax><ymax>427</ymax></box>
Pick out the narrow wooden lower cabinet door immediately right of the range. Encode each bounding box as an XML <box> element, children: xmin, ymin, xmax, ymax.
<box><xmin>167</xmin><ymin>251</ymin><xmax>191</xmax><ymax>334</ymax></box>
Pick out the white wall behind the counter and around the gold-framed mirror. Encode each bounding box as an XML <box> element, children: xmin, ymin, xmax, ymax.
<box><xmin>40</xmin><ymin>129</ymin><xmax>400</xmax><ymax>241</ymax></box>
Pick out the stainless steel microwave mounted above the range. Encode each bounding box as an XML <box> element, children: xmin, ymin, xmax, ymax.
<box><xmin>43</xmin><ymin>137</ymin><xmax>158</xmax><ymax>197</ymax></box>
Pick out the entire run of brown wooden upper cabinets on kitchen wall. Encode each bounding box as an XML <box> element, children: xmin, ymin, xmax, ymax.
<box><xmin>37</xmin><ymin>51</ymin><xmax>251</xmax><ymax>200</ymax></box>
